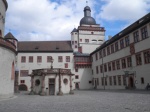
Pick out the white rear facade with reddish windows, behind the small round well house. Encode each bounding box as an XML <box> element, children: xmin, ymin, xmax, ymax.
<box><xmin>17</xmin><ymin>52</ymin><xmax>74</xmax><ymax>91</ymax></box>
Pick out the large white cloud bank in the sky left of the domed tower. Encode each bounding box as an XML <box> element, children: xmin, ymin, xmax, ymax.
<box><xmin>6</xmin><ymin>0</ymin><xmax>93</xmax><ymax>41</ymax></box>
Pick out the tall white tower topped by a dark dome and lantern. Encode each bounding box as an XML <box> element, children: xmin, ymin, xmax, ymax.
<box><xmin>71</xmin><ymin>6</ymin><xmax>105</xmax><ymax>54</ymax></box>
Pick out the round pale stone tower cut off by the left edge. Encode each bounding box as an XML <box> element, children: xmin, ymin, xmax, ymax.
<box><xmin>0</xmin><ymin>0</ymin><xmax>17</xmax><ymax>99</ymax></box>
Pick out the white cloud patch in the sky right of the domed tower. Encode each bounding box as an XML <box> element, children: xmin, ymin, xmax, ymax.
<box><xmin>99</xmin><ymin>0</ymin><xmax>150</xmax><ymax>22</ymax></box>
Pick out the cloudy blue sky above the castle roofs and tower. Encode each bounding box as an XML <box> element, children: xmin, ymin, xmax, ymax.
<box><xmin>5</xmin><ymin>0</ymin><xmax>150</xmax><ymax>41</ymax></box>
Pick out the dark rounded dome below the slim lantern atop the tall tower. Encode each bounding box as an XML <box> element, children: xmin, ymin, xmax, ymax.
<box><xmin>80</xmin><ymin>16</ymin><xmax>96</xmax><ymax>25</ymax></box>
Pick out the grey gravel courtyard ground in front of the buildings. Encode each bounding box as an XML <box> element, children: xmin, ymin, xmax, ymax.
<box><xmin>0</xmin><ymin>90</ymin><xmax>150</xmax><ymax>112</ymax></box>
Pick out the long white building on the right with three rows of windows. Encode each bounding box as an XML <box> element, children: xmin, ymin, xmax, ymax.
<box><xmin>91</xmin><ymin>14</ymin><xmax>150</xmax><ymax>89</ymax></box>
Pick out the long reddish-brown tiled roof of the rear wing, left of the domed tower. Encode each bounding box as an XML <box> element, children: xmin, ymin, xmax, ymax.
<box><xmin>18</xmin><ymin>41</ymin><xmax>73</xmax><ymax>52</ymax></box>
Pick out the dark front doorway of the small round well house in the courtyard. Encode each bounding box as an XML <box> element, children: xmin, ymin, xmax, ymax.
<box><xmin>49</xmin><ymin>78</ymin><xmax>55</xmax><ymax>95</ymax></box>
